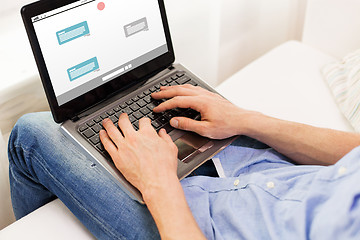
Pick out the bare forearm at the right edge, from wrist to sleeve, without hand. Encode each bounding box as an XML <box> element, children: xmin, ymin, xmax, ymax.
<box><xmin>240</xmin><ymin>113</ymin><xmax>360</xmax><ymax>165</ymax></box>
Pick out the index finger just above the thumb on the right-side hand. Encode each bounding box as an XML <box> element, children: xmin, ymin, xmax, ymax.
<box><xmin>153</xmin><ymin>96</ymin><xmax>204</xmax><ymax>112</ymax></box>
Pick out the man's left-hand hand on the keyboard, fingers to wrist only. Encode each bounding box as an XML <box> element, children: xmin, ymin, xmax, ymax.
<box><xmin>100</xmin><ymin>114</ymin><xmax>178</xmax><ymax>195</ymax></box>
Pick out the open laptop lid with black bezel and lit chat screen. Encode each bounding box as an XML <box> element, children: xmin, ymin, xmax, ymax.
<box><xmin>21</xmin><ymin>0</ymin><xmax>175</xmax><ymax>123</ymax></box>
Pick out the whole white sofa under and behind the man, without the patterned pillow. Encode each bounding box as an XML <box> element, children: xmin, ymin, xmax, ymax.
<box><xmin>0</xmin><ymin>0</ymin><xmax>360</xmax><ymax>239</ymax></box>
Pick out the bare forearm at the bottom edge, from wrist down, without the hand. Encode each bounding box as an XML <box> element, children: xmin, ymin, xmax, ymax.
<box><xmin>144</xmin><ymin>175</ymin><xmax>205</xmax><ymax>239</ymax></box>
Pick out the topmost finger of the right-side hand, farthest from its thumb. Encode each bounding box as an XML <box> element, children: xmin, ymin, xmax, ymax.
<box><xmin>151</xmin><ymin>85</ymin><xmax>198</xmax><ymax>99</ymax></box>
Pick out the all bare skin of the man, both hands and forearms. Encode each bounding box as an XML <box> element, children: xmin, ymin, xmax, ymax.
<box><xmin>100</xmin><ymin>85</ymin><xmax>360</xmax><ymax>239</ymax></box>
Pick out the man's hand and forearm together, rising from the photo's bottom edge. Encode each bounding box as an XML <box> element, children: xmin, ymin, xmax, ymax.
<box><xmin>100</xmin><ymin>114</ymin><xmax>204</xmax><ymax>239</ymax></box>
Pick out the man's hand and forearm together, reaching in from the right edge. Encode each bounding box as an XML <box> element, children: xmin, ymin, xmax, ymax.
<box><xmin>153</xmin><ymin>85</ymin><xmax>360</xmax><ymax>165</ymax></box>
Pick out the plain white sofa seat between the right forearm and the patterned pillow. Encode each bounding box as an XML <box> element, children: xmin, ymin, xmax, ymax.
<box><xmin>217</xmin><ymin>41</ymin><xmax>353</xmax><ymax>131</ymax></box>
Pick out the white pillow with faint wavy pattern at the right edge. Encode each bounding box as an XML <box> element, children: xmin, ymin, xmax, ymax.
<box><xmin>323</xmin><ymin>49</ymin><xmax>360</xmax><ymax>132</ymax></box>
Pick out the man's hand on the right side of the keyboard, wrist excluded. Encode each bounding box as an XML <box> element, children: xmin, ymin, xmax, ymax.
<box><xmin>152</xmin><ymin>84</ymin><xmax>257</xmax><ymax>139</ymax></box>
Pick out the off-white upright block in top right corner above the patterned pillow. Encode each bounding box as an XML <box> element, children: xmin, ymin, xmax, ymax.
<box><xmin>302</xmin><ymin>0</ymin><xmax>360</xmax><ymax>58</ymax></box>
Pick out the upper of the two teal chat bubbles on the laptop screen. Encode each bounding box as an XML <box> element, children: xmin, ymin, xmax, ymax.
<box><xmin>56</xmin><ymin>21</ymin><xmax>90</xmax><ymax>45</ymax></box>
